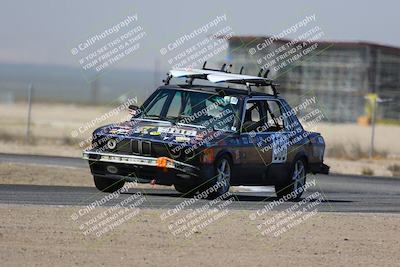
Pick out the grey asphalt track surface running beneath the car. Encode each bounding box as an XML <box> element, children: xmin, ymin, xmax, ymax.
<box><xmin>0</xmin><ymin>154</ymin><xmax>400</xmax><ymax>213</ymax></box>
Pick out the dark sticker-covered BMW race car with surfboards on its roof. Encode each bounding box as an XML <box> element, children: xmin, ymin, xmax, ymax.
<box><xmin>83</xmin><ymin>65</ymin><xmax>329</xmax><ymax>199</ymax></box>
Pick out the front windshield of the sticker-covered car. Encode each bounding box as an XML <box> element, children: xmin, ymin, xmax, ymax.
<box><xmin>141</xmin><ymin>89</ymin><xmax>239</xmax><ymax>131</ymax></box>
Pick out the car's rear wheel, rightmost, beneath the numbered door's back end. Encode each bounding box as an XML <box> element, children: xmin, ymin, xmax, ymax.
<box><xmin>275</xmin><ymin>158</ymin><xmax>307</xmax><ymax>200</ymax></box>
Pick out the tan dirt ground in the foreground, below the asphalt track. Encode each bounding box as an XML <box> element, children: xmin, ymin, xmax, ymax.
<box><xmin>0</xmin><ymin>205</ymin><xmax>400</xmax><ymax>266</ymax></box>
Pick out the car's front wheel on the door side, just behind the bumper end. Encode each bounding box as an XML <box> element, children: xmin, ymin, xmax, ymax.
<box><xmin>202</xmin><ymin>156</ymin><xmax>232</xmax><ymax>199</ymax></box>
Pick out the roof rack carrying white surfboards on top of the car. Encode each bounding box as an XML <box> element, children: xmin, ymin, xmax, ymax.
<box><xmin>163</xmin><ymin>61</ymin><xmax>278</xmax><ymax>96</ymax></box>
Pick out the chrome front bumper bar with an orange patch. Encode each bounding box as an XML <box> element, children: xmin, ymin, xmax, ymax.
<box><xmin>82</xmin><ymin>150</ymin><xmax>199</xmax><ymax>176</ymax></box>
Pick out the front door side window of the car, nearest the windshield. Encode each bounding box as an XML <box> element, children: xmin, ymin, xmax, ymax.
<box><xmin>242</xmin><ymin>101</ymin><xmax>265</xmax><ymax>132</ymax></box>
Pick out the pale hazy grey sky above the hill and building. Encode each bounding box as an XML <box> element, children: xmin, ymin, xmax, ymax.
<box><xmin>0</xmin><ymin>0</ymin><xmax>400</xmax><ymax>69</ymax></box>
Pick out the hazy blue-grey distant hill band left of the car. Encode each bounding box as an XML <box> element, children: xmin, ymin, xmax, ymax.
<box><xmin>0</xmin><ymin>63</ymin><xmax>164</xmax><ymax>103</ymax></box>
